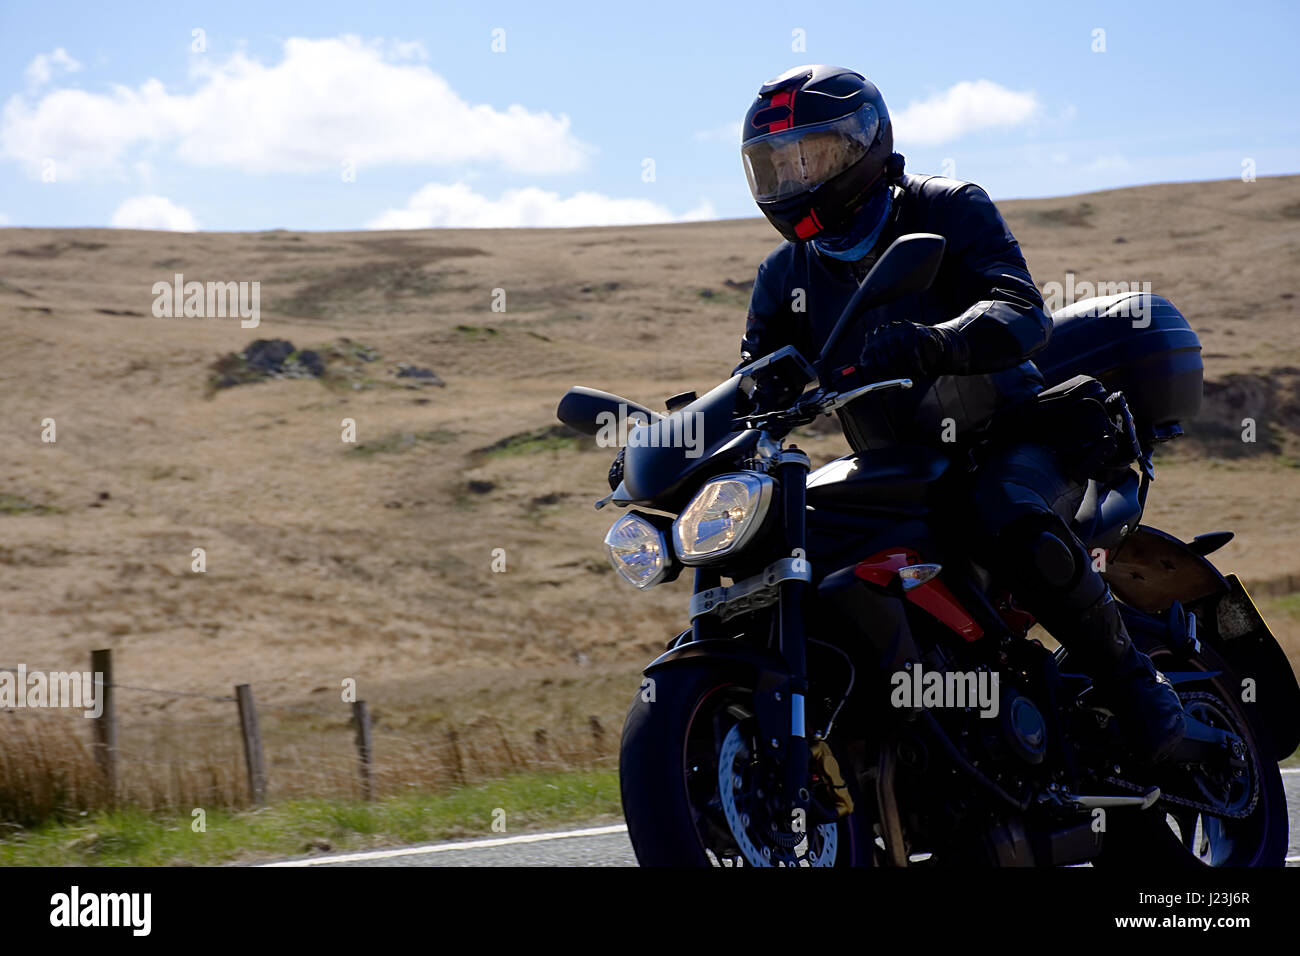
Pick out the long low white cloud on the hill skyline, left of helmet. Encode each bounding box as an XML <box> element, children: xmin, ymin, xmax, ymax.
<box><xmin>367</xmin><ymin>182</ymin><xmax>716</xmax><ymax>229</ymax></box>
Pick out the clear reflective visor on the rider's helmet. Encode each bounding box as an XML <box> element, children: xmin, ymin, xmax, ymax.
<box><xmin>740</xmin><ymin>103</ymin><xmax>880</xmax><ymax>203</ymax></box>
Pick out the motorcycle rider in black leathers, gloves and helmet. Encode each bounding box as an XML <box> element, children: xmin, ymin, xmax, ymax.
<box><xmin>737</xmin><ymin>65</ymin><xmax>1186</xmax><ymax>762</ymax></box>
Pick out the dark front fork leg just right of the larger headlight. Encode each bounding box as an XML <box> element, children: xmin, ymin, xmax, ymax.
<box><xmin>776</xmin><ymin>446</ymin><xmax>810</xmax><ymax>823</ymax></box>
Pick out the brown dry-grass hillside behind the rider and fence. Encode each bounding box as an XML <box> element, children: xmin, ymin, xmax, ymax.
<box><xmin>0</xmin><ymin>177</ymin><xmax>1300</xmax><ymax>816</ymax></box>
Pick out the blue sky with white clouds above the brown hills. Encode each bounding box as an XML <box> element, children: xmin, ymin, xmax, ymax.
<box><xmin>0</xmin><ymin>0</ymin><xmax>1300</xmax><ymax>230</ymax></box>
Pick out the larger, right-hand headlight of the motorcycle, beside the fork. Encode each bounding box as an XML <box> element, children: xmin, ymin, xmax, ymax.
<box><xmin>672</xmin><ymin>472</ymin><xmax>776</xmax><ymax>564</ymax></box>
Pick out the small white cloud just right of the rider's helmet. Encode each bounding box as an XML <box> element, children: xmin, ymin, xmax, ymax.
<box><xmin>892</xmin><ymin>79</ymin><xmax>1039</xmax><ymax>146</ymax></box>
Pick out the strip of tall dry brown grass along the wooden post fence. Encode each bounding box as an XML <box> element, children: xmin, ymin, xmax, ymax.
<box><xmin>0</xmin><ymin>686</ymin><xmax>618</xmax><ymax>827</ymax></box>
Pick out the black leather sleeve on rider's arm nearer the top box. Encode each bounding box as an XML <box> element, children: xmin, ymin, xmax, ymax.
<box><xmin>937</xmin><ymin>183</ymin><xmax>1052</xmax><ymax>375</ymax></box>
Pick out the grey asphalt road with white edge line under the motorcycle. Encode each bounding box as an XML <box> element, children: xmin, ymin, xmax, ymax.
<box><xmin>265</xmin><ymin>769</ymin><xmax>1300</xmax><ymax>868</ymax></box>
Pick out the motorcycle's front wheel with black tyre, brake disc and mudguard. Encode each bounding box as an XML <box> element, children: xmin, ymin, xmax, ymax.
<box><xmin>619</xmin><ymin>661</ymin><xmax>871</xmax><ymax>866</ymax></box>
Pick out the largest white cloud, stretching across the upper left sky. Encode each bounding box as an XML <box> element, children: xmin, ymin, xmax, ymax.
<box><xmin>0</xmin><ymin>36</ymin><xmax>590</xmax><ymax>178</ymax></box>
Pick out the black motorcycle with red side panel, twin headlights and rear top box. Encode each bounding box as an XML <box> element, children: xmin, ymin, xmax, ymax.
<box><xmin>556</xmin><ymin>234</ymin><xmax>1300</xmax><ymax>866</ymax></box>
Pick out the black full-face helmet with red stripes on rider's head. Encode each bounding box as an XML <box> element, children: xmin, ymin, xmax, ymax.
<box><xmin>740</xmin><ymin>66</ymin><xmax>902</xmax><ymax>242</ymax></box>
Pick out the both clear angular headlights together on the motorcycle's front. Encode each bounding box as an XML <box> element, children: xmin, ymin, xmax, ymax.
<box><xmin>605</xmin><ymin>472</ymin><xmax>776</xmax><ymax>588</ymax></box>
